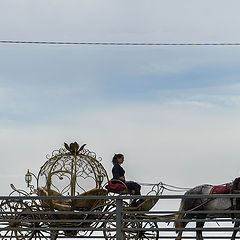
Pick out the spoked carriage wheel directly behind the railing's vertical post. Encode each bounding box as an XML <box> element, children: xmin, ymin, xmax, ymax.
<box><xmin>103</xmin><ymin>215</ymin><xmax>140</xmax><ymax>240</ymax></box>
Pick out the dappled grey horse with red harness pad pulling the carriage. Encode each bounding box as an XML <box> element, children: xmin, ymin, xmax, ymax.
<box><xmin>174</xmin><ymin>178</ymin><xmax>240</xmax><ymax>240</ymax></box>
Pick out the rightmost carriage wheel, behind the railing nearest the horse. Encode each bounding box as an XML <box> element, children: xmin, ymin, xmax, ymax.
<box><xmin>138</xmin><ymin>222</ymin><xmax>159</xmax><ymax>240</ymax></box>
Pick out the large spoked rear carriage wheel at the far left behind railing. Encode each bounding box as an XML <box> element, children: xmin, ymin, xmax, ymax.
<box><xmin>0</xmin><ymin>200</ymin><xmax>36</xmax><ymax>240</ymax></box>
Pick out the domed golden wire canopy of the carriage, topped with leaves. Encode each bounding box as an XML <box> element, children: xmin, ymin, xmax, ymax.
<box><xmin>25</xmin><ymin>142</ymin><xmax>108</xmax><ymax>196</ymax></box>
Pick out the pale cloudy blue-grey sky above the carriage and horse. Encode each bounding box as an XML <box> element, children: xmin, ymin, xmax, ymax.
<box><xmin>0</xmin><ymin>0</ymin><xmax>240</xmax><ymax>201</ymax></box>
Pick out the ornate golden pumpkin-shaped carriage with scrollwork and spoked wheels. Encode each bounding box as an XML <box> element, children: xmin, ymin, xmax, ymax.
<box><xmin>0</xmin><ymin>142</ymin><xmax>163</xmax><ymax>240</ymax></box>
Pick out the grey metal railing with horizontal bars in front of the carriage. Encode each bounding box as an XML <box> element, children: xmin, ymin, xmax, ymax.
<box><xmin>0</xmin><ymin>194</ymin><xmax>240</xmax><ymax>240</ymax></box>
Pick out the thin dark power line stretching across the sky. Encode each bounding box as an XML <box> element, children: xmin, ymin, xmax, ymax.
<box><xmin>0</xmin><ymin>40</ymin><xmax>240</xmax><ymax>46</ymax></box>
